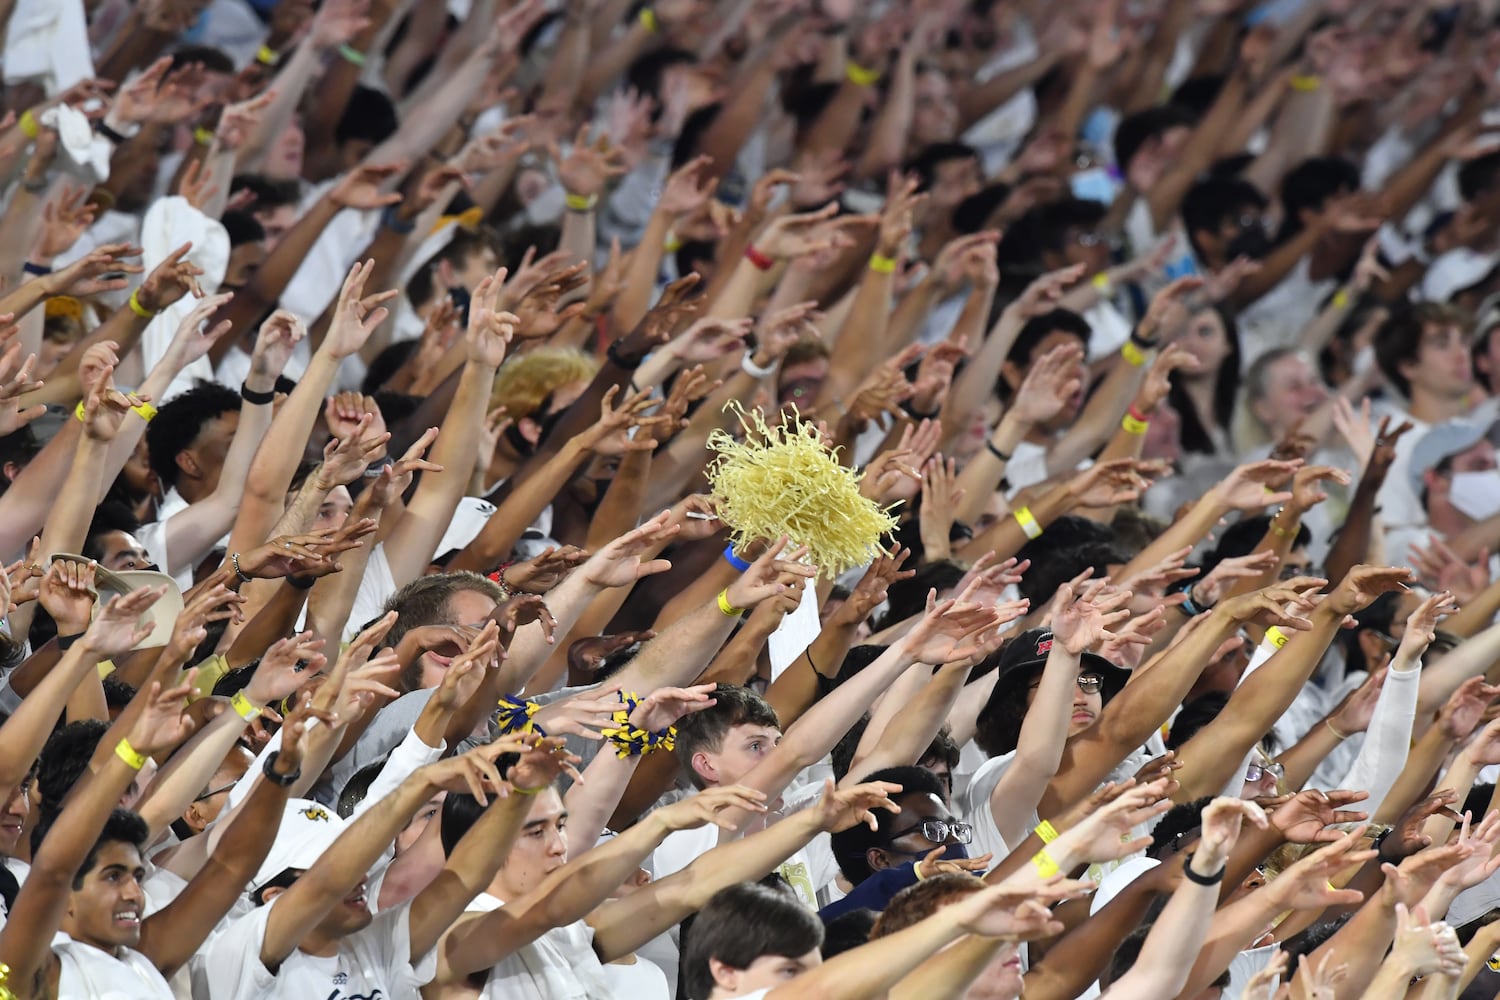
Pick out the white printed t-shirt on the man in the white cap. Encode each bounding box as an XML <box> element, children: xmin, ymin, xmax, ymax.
<box><xmin>194</xmin><ymin>901</ymin><xmax>438</xmax><ymax>1000</ymax></box>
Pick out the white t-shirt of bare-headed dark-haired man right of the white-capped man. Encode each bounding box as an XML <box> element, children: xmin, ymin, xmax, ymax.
<box><xmin>465</xmin><ymin>892</ymin><xmax>612</xmax><ymax>1000</ymax></box>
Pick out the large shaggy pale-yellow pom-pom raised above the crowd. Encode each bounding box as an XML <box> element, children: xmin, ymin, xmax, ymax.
<box><xmin>708</xmin><ymin>406</ymin><xmax>896</xmax><ymax>579</ymax></box>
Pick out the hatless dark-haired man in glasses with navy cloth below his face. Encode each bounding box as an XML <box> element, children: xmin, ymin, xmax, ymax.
<box><xmin>819</xmin><ymin>766</ymin><xmax>989</xmax><ymax>921</ymax></box>
